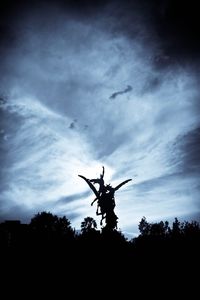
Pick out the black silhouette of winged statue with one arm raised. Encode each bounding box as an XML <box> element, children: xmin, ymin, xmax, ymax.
<box><xmin>78</xmin><ymin>167</ymin><xmax>132</xmax><ymax>230</ymax></box>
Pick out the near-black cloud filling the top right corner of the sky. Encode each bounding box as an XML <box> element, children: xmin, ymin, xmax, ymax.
<box><xmin>104</xmin><ymin>0</ymin><xmax>200</xmax><ymax>67</ymax></box>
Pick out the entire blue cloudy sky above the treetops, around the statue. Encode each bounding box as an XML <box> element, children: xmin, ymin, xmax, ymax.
<box><xmin>0</xmin><ymin>0</ymin><xmax>200</xmax><ymax>236</ymax></box>
